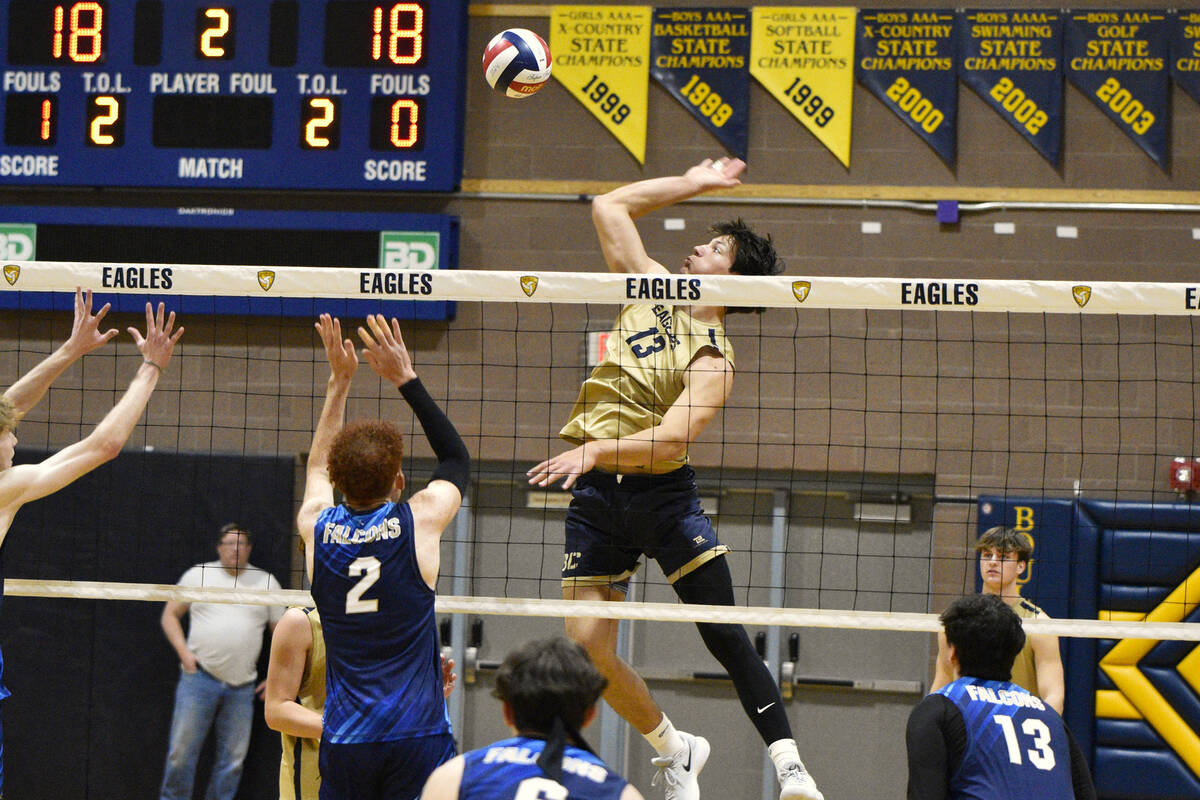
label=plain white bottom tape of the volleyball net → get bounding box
[5,578,1200,642]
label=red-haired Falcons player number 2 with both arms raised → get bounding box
[296,314,470,800]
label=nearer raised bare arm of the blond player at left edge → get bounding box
[0,303,184,525]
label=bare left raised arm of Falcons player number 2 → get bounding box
[296,314,359,578]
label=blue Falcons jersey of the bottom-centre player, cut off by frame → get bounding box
[458,736,628,800]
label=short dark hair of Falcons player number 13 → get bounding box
[938,595,1025,680]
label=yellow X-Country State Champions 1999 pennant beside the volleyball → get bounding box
[550,6,650,164]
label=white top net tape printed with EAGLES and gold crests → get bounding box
[11,261,1200,315]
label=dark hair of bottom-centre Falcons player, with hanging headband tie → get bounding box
[493,636,608,781]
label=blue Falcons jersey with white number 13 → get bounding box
[935,678,1075,800]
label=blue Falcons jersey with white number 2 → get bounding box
[312,503,450,744]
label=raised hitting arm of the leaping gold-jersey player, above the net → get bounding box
[592,158,746,272]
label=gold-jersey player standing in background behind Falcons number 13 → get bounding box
[931,525,1067,714]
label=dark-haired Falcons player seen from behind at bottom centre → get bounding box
[421,636,642,800]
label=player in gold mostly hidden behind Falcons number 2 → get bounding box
[263,607,458,800]
